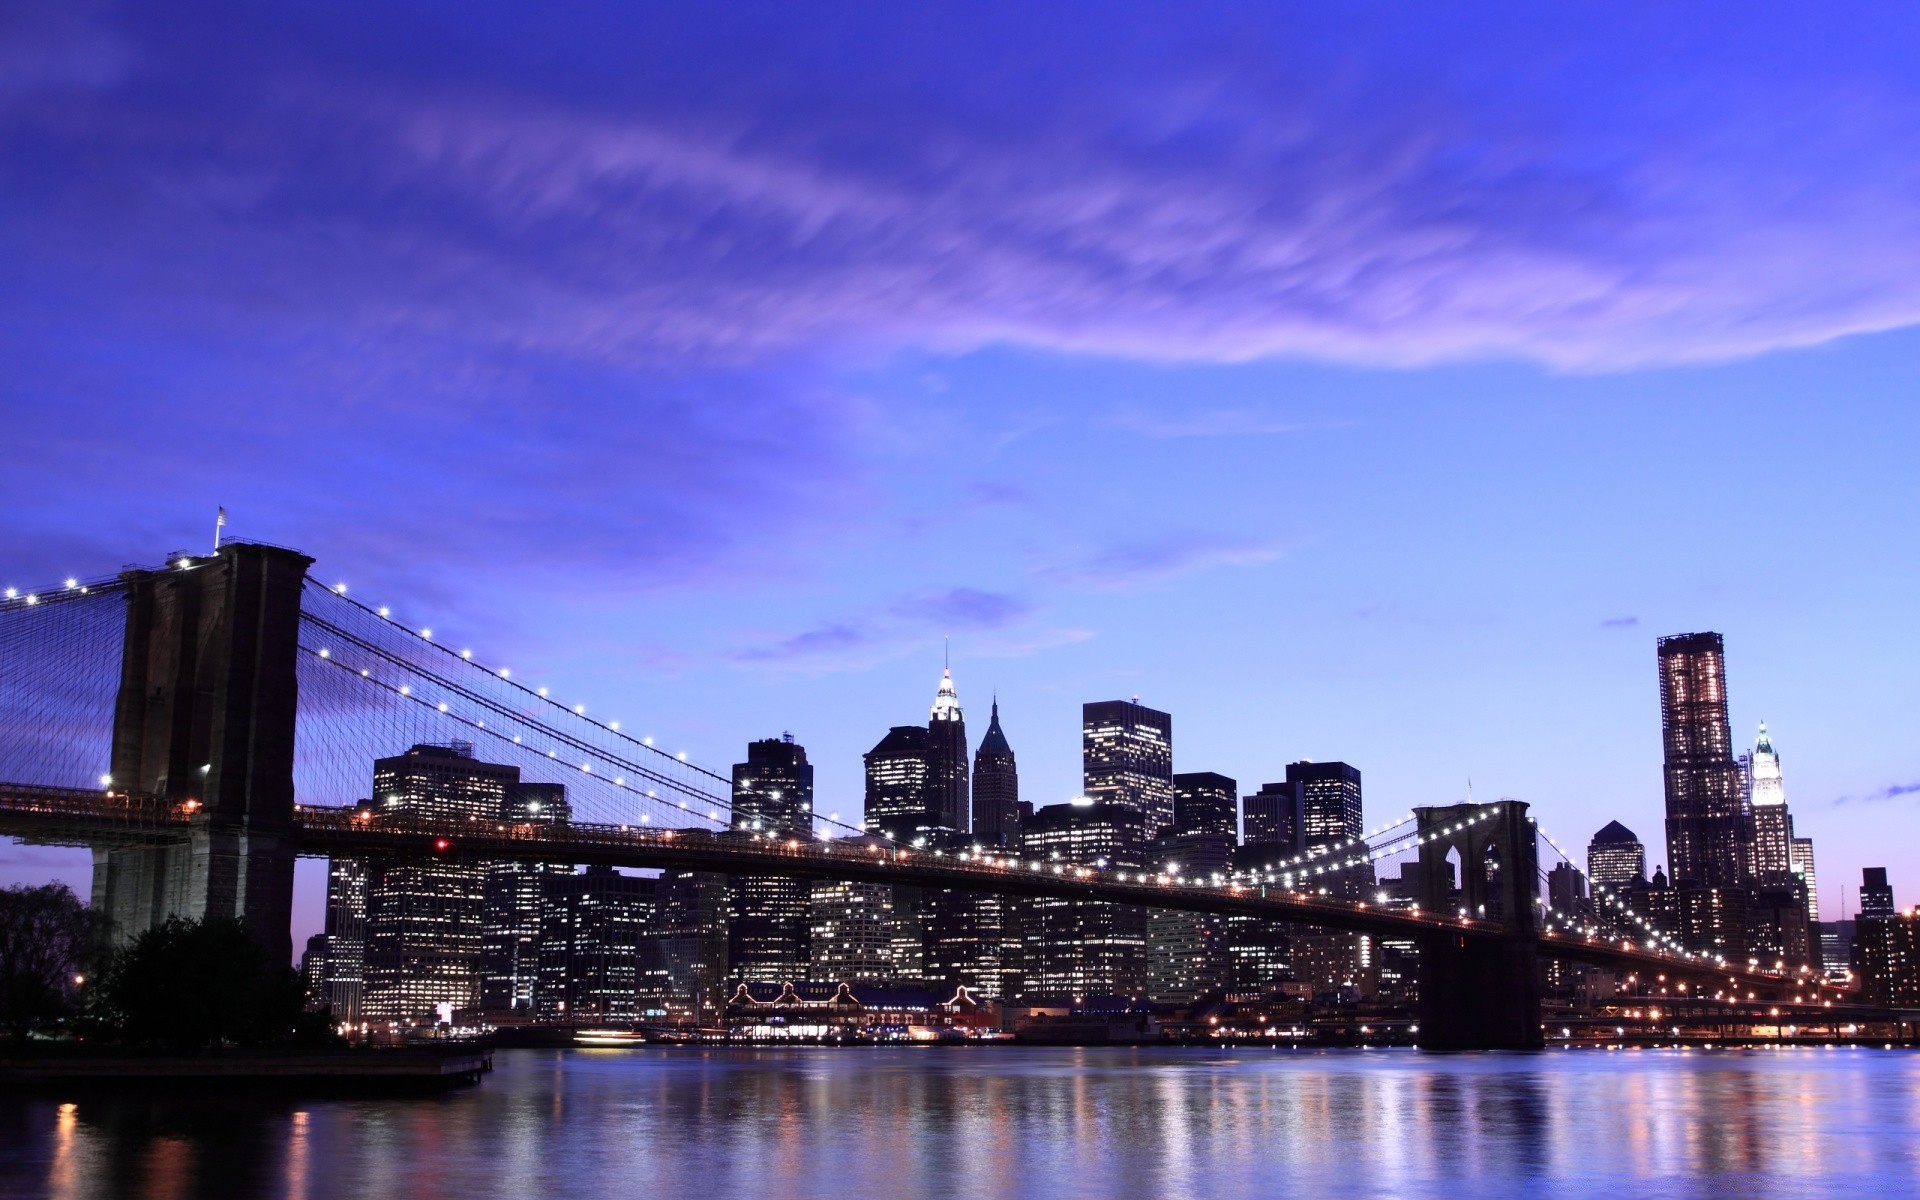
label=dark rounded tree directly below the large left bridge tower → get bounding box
[98,918,324,1050]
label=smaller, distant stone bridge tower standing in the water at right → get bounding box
[1413,801,1544,1050]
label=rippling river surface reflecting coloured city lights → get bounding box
[0,1046,1920,1200]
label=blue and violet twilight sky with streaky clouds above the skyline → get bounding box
[0,0,1920,933]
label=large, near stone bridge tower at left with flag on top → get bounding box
[92,543,313,962]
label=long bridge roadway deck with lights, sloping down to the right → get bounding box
[0,783,1851,1002]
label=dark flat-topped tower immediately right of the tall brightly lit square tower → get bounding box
[1146,821,1236,1004]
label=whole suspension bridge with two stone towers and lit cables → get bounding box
[0,541,1849,1048]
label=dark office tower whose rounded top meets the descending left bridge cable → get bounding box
[728,733,814,983]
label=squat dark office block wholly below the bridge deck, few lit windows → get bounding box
[536,866,659,1025]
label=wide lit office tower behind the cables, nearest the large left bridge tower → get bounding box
[363,743,520,1021]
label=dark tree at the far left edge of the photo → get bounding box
[0,883,86,1048]
